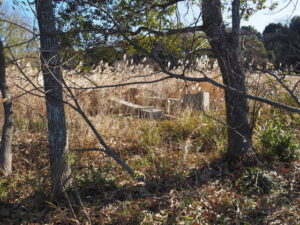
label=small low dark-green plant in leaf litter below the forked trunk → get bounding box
[236,168,279,194]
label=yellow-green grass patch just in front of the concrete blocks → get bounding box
[138,111,226,151]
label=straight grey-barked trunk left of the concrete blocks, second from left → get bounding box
[36,0,71,196]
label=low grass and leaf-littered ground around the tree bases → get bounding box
[0,97,300,225]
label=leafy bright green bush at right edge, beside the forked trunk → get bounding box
[260,120,300,161]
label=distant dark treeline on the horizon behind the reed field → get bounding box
[57,16,300,73]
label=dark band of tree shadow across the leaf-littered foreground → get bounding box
[0,155,299,224]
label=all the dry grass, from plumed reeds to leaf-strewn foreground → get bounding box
[0,60,300,225]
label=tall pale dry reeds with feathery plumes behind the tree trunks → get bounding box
[0,57,298,153]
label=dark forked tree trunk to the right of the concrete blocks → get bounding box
[202,0,252,159]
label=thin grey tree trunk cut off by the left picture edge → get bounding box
[0,40,14,175]
